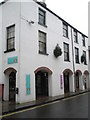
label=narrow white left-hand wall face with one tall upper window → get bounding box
[2,2,20,101]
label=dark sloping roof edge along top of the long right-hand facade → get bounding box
[36,2,88,38]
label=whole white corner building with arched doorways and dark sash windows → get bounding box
[0,0,89,103]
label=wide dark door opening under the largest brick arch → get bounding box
[35,71,48,99]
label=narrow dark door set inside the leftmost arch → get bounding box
[9,72,16,102]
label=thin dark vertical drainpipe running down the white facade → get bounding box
[71,28,76,92]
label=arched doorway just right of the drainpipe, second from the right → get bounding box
[75,70,83,91]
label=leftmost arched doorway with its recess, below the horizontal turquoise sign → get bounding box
[4,68,17,102]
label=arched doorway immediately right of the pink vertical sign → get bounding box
[63,69,73,93]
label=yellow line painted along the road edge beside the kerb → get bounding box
[0,93,88,118]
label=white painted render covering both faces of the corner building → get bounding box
[0,0,88,103]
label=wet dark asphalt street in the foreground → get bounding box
[3,93,89,119]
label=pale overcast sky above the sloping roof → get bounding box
[0,0,89,35]
